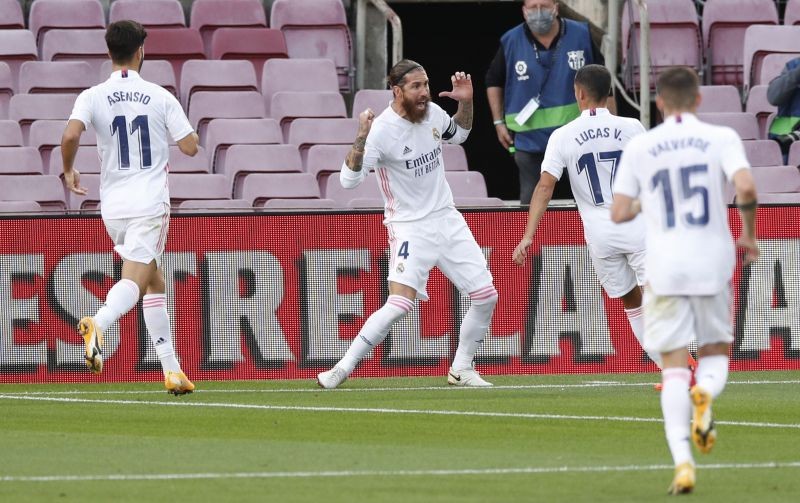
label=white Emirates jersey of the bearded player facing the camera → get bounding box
[362,103,468,223]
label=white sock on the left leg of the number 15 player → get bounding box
[661,367,694,466]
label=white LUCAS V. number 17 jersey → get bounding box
[542,108,645,258]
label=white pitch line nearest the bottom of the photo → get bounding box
[0,461,800,482]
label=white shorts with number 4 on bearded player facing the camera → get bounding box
[386,210,492,300]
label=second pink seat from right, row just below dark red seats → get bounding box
[180,60,258,110]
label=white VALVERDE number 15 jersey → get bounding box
[614,113,750,295]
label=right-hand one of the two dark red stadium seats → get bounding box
[211,28,289,90]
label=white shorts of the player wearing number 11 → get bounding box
[103,212,169,267]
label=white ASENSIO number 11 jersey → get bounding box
[70,70,193,218]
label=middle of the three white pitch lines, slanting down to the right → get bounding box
[0,394,800,429]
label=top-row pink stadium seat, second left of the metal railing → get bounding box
[189,0,267,55]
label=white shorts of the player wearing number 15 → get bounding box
[643,286,733,353]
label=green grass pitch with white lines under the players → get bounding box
[0,372,800,503]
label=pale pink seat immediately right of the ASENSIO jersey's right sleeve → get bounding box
[189,91,264,138]
